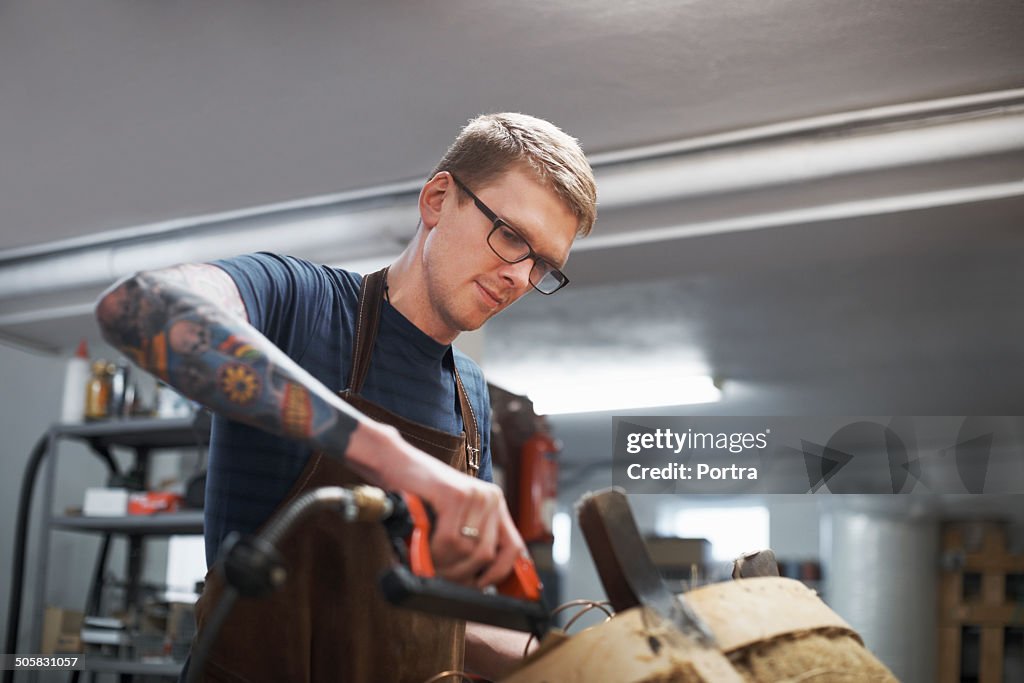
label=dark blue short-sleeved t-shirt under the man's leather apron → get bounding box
[205,253,492,565]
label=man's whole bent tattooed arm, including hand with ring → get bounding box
[96,264,525,586]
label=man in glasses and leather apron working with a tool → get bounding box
[96,114,596,682]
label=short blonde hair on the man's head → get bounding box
[430,113,597,237]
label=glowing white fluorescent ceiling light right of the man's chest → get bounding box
[499,366,722,415]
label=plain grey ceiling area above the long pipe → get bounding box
[0,0,1024,249]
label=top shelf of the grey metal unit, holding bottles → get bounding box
[52,411,210,449]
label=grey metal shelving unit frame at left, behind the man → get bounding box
[29,413,210,680]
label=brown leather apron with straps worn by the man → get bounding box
[196,268,480,683]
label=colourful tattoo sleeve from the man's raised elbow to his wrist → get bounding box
[96,266,361,456]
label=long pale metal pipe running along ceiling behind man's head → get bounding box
[0,90,1024,328]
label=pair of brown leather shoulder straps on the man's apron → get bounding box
[346,266,480,476]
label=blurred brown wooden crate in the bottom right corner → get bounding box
[938,521,1024,683]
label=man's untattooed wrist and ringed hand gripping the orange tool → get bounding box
[346,423,526,588]
